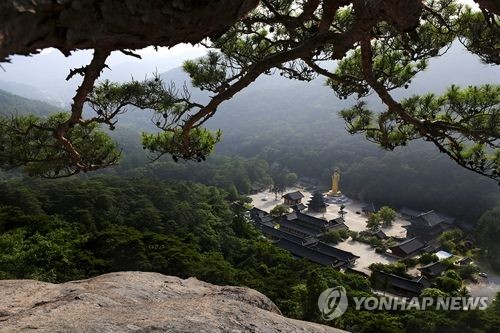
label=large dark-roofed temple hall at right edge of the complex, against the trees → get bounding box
[404,210,450,242]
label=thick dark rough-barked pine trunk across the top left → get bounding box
[0,0,259,61]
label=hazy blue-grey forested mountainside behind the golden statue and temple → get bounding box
[2,43,500,221]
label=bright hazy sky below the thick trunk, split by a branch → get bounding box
[0,45,205,105]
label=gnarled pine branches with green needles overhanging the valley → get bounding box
[0,0,500,180]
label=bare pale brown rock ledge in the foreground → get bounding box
[0,272,341,333]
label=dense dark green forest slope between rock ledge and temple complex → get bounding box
[0,176,500,332]
